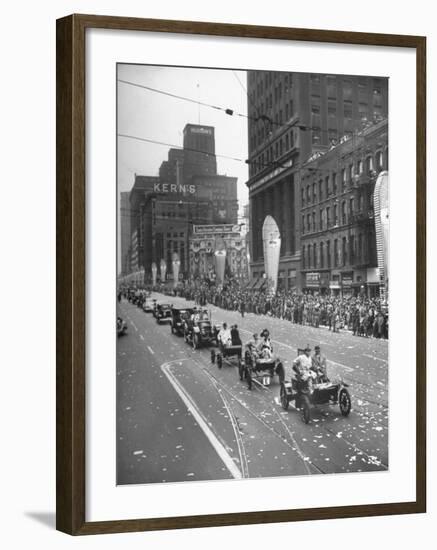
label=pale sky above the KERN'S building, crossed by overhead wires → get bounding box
[118,64,248,207]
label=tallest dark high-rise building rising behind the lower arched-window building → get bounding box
[247,71,388,289]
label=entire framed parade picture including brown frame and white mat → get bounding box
[56,15,426,535]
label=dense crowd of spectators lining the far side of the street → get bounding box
[159,279,388,338]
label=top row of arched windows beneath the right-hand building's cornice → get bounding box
[301,151,384,206]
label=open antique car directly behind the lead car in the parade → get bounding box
[238,348,285,390]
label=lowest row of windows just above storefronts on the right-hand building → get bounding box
[302,233,366,269]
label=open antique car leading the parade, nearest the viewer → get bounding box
[280,349,352,424]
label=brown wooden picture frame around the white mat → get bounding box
[56,15,426,535]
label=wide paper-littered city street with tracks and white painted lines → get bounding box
[117,293,389,484]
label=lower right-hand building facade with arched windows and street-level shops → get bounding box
[300,119,388,297]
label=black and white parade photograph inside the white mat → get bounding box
[116,63,390,485]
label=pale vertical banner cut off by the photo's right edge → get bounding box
[373,174,389,298]
